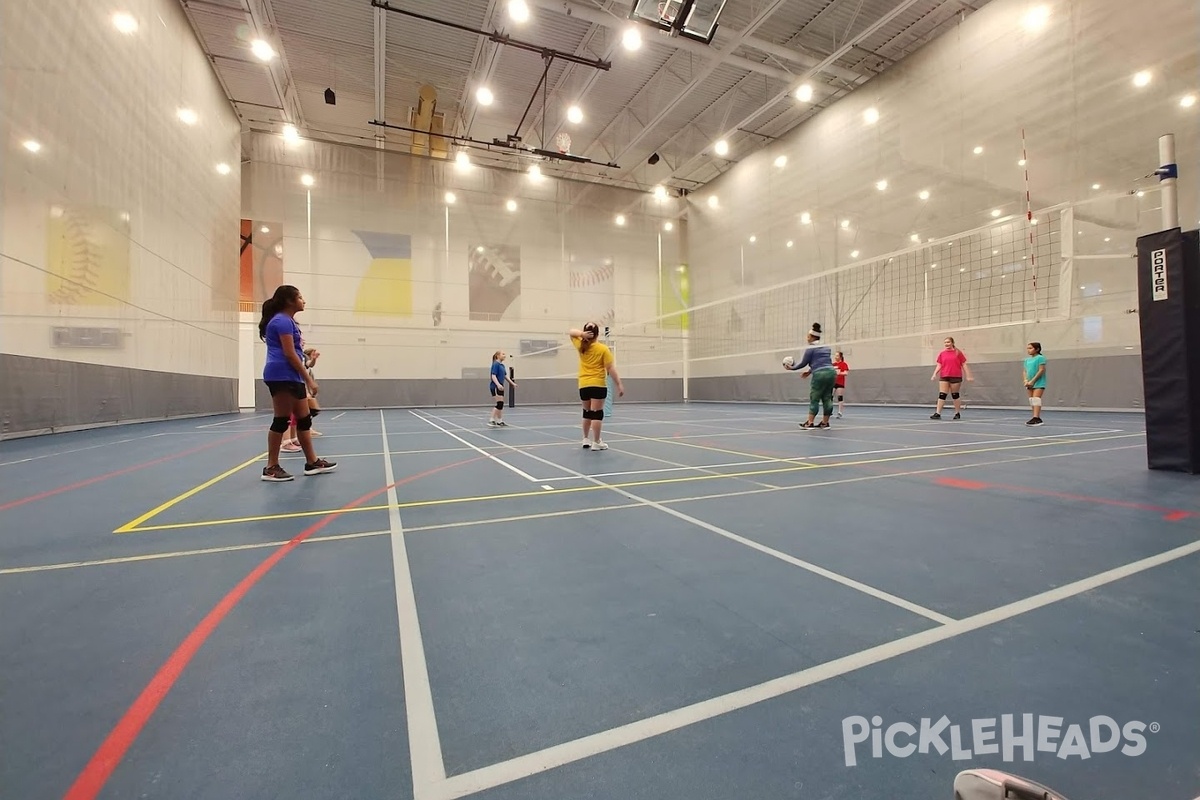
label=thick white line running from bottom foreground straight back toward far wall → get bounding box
[379,410,446,800]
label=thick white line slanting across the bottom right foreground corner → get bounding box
[428,532,1200,800]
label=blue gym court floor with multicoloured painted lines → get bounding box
[0,402,1200,800]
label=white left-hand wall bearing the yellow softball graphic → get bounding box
[0,0,240,380]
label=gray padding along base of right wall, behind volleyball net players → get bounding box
[688,355,1144,410]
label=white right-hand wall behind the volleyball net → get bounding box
[689,0,1200,375]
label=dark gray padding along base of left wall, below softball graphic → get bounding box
[0,354,238,438]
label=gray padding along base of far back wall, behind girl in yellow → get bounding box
[254,378,683,410]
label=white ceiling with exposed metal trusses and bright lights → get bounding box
[180,0,988,188]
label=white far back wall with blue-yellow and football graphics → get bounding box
[244,134,680,380]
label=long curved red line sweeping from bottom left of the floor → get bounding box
[64,457,482,800]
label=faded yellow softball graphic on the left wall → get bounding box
[46,206,130,306]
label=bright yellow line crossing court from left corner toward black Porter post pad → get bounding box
[114,433,1144,533]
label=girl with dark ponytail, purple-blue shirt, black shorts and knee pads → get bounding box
[258,285,337,481]
